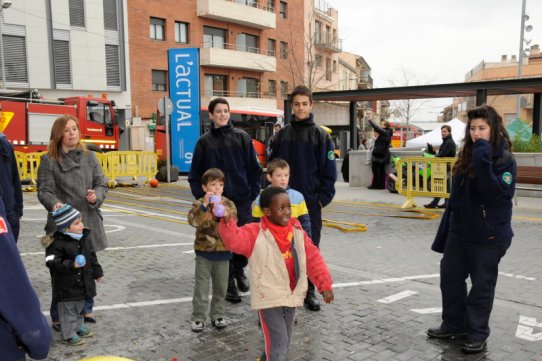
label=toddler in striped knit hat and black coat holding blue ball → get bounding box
[42,204,103,346]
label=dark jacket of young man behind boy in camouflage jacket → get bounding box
[188,121,262,203]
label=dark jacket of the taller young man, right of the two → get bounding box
[269,113,337,209]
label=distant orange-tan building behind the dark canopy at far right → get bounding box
[452,45,542,124]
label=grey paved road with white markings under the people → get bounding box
[19,181,542,361]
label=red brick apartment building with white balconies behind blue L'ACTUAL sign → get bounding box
[128,0,304,118]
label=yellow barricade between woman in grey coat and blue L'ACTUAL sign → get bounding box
[98,151,158,181]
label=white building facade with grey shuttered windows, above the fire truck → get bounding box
[0,0,131,112]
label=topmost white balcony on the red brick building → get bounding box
[197,0,277,29]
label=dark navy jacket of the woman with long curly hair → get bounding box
[431,140,516,252]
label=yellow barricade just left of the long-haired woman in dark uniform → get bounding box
[395,157,456,208]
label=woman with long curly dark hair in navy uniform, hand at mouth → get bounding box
[427,106,516,353]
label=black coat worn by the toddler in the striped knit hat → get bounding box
[45,229,103,302]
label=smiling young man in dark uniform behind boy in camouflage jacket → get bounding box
[188,98,262,303]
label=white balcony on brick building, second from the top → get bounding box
[200,42,277,72]
